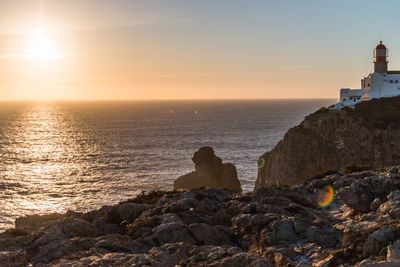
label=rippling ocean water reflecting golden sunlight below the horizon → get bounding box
[0,99,334,231]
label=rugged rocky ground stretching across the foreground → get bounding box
[0,167,400,267]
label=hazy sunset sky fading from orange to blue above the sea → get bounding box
[0,0,400,100]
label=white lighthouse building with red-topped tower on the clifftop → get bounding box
[332,42,400,109]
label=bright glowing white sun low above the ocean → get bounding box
[26,32,64,61]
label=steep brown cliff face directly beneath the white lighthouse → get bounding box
[255,97,400,189]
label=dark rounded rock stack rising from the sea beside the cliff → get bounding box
[174,147,242,192]
